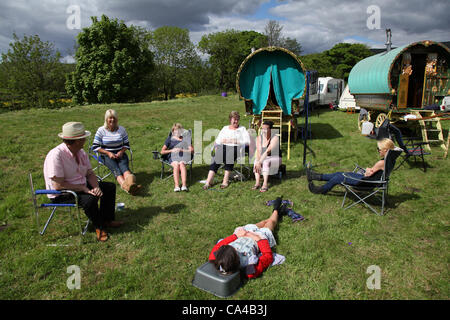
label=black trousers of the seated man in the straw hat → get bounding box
[52,181,116,229]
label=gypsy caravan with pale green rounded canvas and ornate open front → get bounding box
[348,40,450,149]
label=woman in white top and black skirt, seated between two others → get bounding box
[203,111,250,190]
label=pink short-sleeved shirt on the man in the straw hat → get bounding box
[44,143,92,198]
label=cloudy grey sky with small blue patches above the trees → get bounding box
[0,0,450,62]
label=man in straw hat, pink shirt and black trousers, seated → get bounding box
[44,122,123,242]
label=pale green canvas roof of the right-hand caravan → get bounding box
[348,40,449,94]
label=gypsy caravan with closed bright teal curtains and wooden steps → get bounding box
[236,47,306,159]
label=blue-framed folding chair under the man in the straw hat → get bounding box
[29,173,90,236]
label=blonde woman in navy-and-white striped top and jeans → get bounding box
[92,109,141,195]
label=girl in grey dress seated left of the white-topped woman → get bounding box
[160,123,194,192]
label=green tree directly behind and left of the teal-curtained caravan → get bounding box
[198,30,267,90]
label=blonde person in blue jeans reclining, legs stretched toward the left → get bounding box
[306,139,395,194]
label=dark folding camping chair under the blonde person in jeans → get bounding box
[341,148,402,215]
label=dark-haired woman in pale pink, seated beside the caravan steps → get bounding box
[252,121,281,192]
